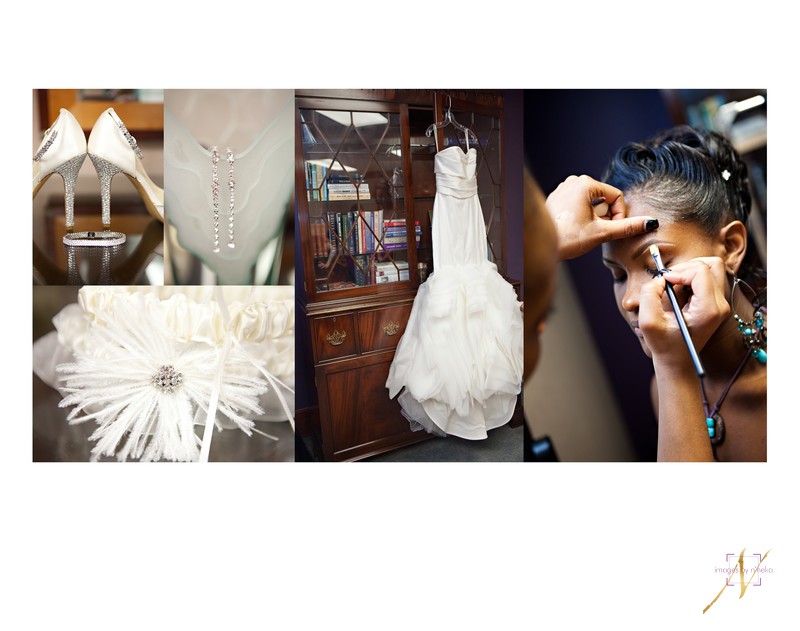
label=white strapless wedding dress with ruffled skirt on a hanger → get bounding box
[386,145,523,440]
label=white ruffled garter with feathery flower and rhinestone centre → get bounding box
[34,287,294,461]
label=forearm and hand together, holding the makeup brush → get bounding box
[639,258,730,462]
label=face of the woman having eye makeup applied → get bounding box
[603,194,724,357]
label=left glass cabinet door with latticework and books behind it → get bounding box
[299,101,420,297]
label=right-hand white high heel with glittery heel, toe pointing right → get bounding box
[88,107,164,228]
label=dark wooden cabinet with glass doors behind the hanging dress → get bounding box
[295,90,505,460]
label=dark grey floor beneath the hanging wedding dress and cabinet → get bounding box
[363,426,522,462]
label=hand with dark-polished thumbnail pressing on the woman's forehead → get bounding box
[545,175,658,260]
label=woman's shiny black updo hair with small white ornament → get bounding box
[603,126,755,284]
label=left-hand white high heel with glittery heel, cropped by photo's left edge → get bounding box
[33,108,86,232]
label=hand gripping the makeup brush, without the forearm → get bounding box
[639,257,731,363]
